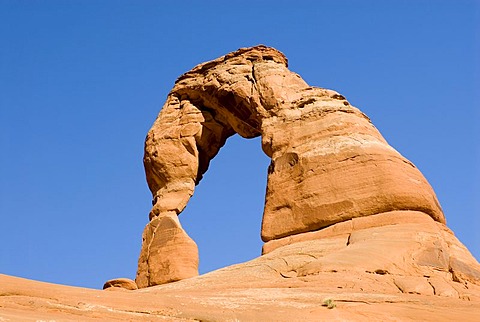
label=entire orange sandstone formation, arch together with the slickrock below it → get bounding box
[0,46,480,322]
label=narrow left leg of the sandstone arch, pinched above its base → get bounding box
[136,92,234,288]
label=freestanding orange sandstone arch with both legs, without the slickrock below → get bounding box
[136,45,445,287]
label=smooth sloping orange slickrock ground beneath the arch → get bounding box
[0,212,480,322]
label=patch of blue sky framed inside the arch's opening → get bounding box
[179,135,270,274]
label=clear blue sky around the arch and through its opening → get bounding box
[0,0,480,288]
